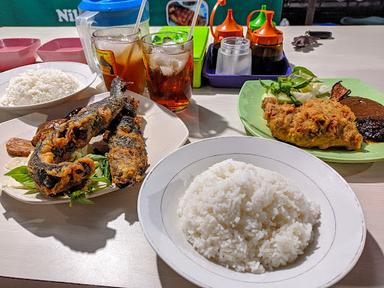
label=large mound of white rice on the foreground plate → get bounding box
[178,159,320,273]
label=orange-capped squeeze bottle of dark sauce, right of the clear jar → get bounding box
[247,10,284,75]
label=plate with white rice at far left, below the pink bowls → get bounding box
[0,61,97,112]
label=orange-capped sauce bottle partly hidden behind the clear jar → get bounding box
[209,0,243,68]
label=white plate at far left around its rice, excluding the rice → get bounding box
[0,61,97,112]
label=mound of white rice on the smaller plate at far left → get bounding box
[0,69,80,106]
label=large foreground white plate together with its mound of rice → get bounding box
[138,136,366,288]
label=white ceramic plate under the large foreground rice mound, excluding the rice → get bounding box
[138,137,366,288]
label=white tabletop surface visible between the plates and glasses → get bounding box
[0,26,384,288]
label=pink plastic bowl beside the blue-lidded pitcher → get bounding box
[37,38,87,64]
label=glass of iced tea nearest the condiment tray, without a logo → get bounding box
[141,32,193,112]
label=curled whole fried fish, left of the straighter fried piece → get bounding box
[28,78,126,196]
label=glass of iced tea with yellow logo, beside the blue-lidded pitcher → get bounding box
[92,27,145,94]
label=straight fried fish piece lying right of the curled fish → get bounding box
[108,102,148,187]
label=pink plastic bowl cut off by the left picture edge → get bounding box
[0,38,41,71]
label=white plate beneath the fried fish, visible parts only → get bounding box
[0,92,188,204]
